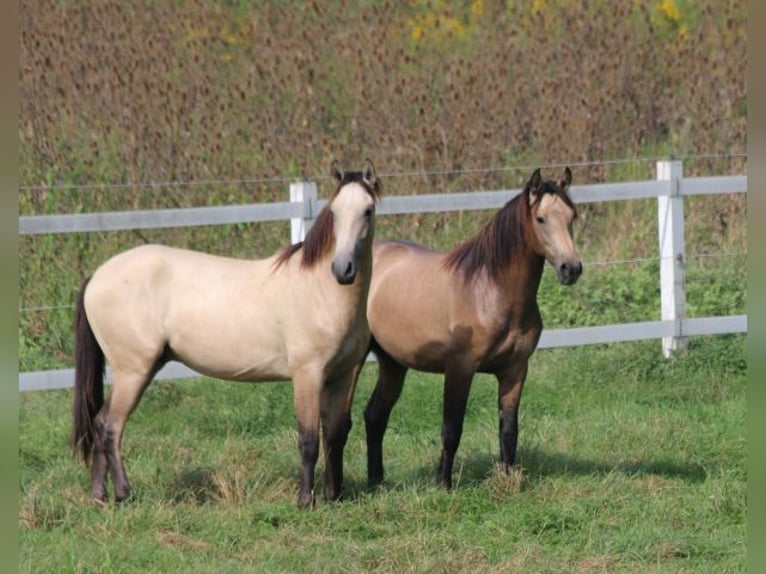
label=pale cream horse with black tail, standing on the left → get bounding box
[72,160,380,507]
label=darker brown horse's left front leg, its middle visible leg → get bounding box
[437,361,474,488]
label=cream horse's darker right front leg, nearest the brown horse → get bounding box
[320,363,362,500]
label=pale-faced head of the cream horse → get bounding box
[330,159,380,285]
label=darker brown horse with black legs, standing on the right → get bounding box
[364,168,582,488]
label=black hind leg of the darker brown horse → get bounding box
[364,350,407,487]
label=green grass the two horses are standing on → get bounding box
[19,336,747,573]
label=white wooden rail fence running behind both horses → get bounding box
[19,161,747,391]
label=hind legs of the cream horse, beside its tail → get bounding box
[99,372,153,502]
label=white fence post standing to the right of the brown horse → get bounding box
[657,161,688,357]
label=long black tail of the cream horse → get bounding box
[72,277,104,464]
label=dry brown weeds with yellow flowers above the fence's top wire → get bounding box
[20,0,747,201]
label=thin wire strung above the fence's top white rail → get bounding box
[18,153,747,192]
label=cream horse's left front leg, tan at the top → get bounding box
[293,369,322,508]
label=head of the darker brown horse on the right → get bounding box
[524,167,582,285]
